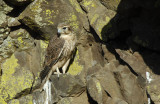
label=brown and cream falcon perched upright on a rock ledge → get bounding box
[40,23,77,90]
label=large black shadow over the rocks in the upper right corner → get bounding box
[101,0,160,75]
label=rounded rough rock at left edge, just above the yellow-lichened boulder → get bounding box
[0,29,34,58]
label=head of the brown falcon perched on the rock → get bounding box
[57,23,72,36]
